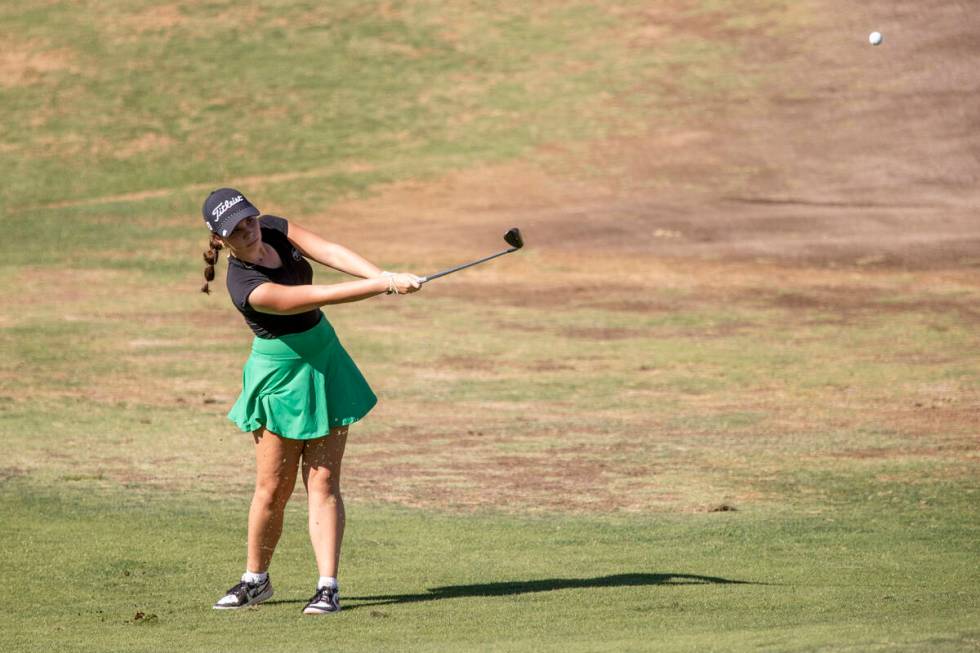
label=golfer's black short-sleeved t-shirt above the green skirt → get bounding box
[227,215,322,338]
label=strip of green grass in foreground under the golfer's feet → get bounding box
[0,478,980,651]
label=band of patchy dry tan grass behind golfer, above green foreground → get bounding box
[0,241,980,512]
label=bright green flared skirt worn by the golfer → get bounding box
[228,310,378,440]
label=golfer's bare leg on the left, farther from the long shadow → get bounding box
[246,428,304,573]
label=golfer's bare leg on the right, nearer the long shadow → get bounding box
[303,426,347,577]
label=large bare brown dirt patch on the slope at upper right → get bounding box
[316,0,980,269]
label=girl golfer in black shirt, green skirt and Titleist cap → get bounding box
[201,188,420,614]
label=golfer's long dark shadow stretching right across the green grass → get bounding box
[267,574,765,611]
